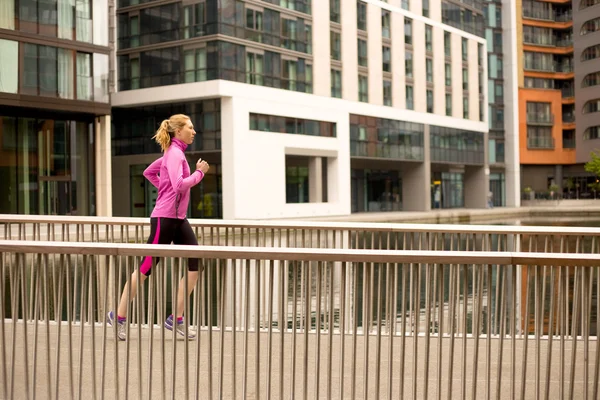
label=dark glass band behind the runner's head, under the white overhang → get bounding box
[111,99,221,155]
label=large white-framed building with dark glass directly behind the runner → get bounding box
[112,0,519,219]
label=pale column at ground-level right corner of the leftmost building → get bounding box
[94,115,112,217]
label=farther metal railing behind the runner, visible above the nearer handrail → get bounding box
[5,216,600,253]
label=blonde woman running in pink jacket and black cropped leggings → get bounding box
[107,114,209,340]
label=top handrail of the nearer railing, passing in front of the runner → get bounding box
[0,240,600,267]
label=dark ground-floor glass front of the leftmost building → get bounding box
[0,109,96,215]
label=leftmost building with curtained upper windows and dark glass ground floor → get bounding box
[0,0,112,215]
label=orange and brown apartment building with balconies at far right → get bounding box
[518,0,600,197]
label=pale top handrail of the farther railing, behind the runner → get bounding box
[0,212,600,236]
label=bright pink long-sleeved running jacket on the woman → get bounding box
[144,138,204,219]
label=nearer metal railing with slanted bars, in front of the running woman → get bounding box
[0,241,600,399]
